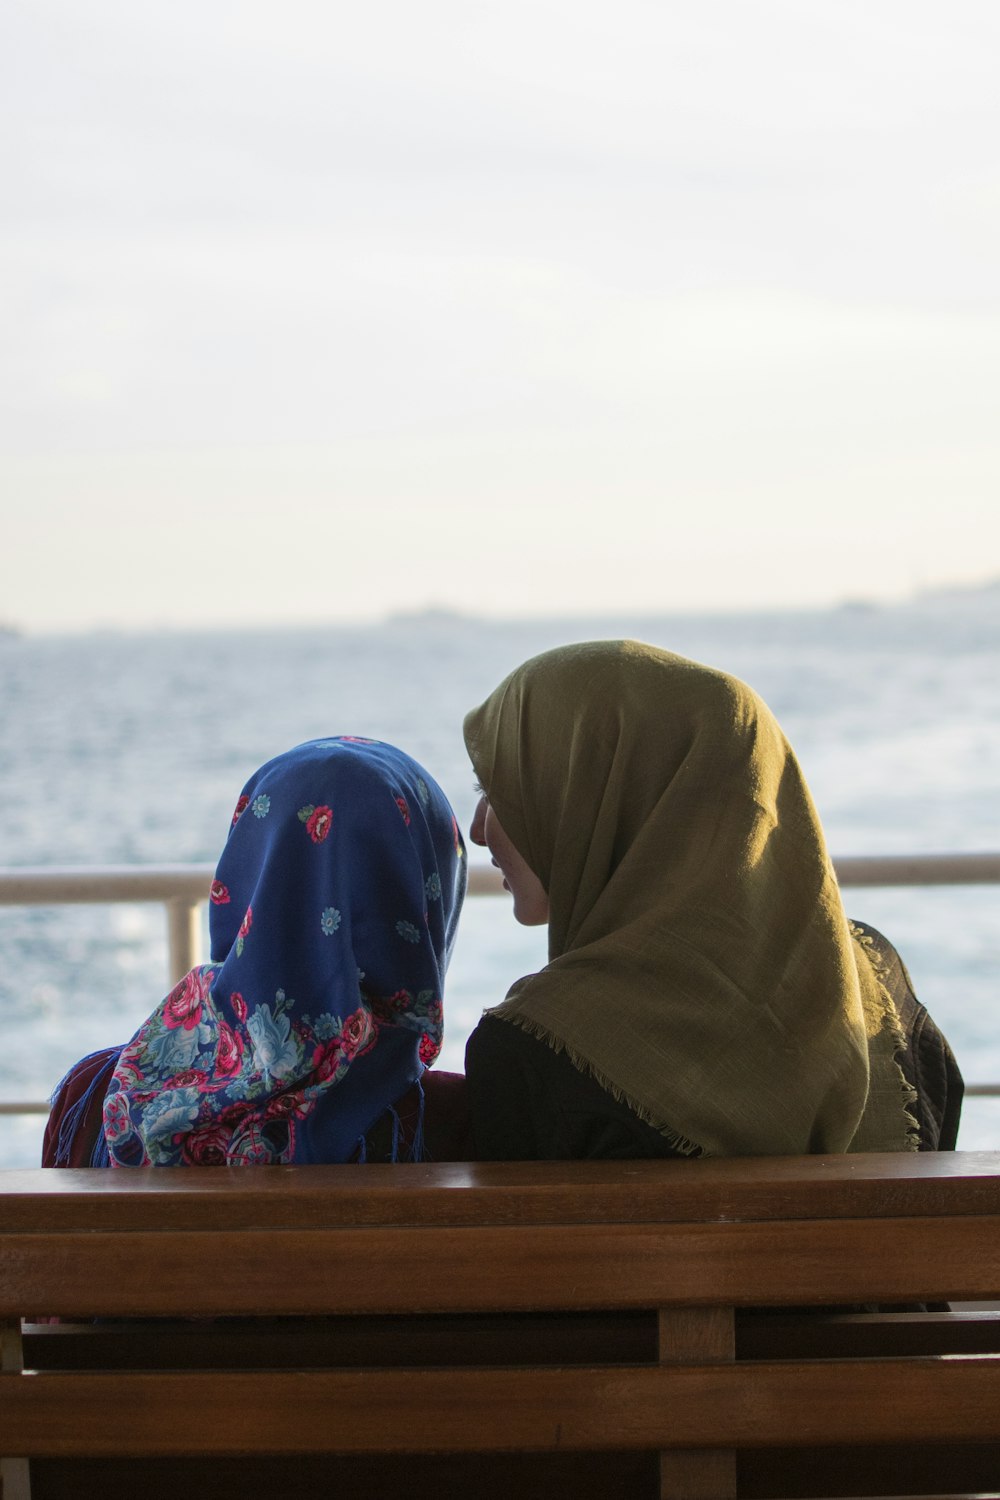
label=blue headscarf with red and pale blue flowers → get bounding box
[103,737,466,1167]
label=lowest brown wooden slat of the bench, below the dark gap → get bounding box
[0,1355,1000,1457]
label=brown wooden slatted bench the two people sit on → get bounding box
[0,1154,1000,1500]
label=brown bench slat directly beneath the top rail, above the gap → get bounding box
[0,1217,1000,1317]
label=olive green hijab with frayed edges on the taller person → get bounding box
[465,641,916,1157]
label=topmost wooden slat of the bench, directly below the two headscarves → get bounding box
[0,1152,1000,1235]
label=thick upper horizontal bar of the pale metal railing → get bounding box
[0,852,1000,906]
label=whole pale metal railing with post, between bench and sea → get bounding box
[0,852,1000,1115]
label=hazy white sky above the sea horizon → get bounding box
[0,0,1000,629]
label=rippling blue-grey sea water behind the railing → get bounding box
[0,588,1000,1166]
